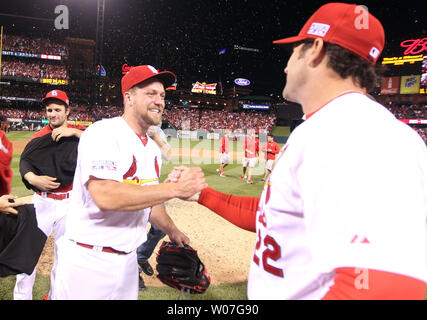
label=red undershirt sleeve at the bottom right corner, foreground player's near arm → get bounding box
[323,268,426,300]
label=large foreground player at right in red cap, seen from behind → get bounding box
[171,3,427,300]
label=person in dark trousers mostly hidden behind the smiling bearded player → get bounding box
[136,124,172,291]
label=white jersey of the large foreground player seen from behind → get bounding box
[248,92,427,299]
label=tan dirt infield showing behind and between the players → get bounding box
[13,141,256,286]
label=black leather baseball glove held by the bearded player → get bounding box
[156,241,210,294]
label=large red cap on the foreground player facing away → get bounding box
[273,3,385,64]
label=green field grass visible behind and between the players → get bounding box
[0,132,264,300]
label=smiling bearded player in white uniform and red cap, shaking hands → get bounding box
[53,65,206,300]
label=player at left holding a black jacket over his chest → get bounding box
[13,90,82,300]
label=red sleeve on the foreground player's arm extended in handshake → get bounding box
[198,188,259,232]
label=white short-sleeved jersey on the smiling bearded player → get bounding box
[66,117,162,252]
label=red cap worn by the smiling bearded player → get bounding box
[122,65,176,96]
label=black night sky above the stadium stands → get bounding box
[0,0,427,94]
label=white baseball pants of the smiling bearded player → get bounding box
[52,237,139,300]
